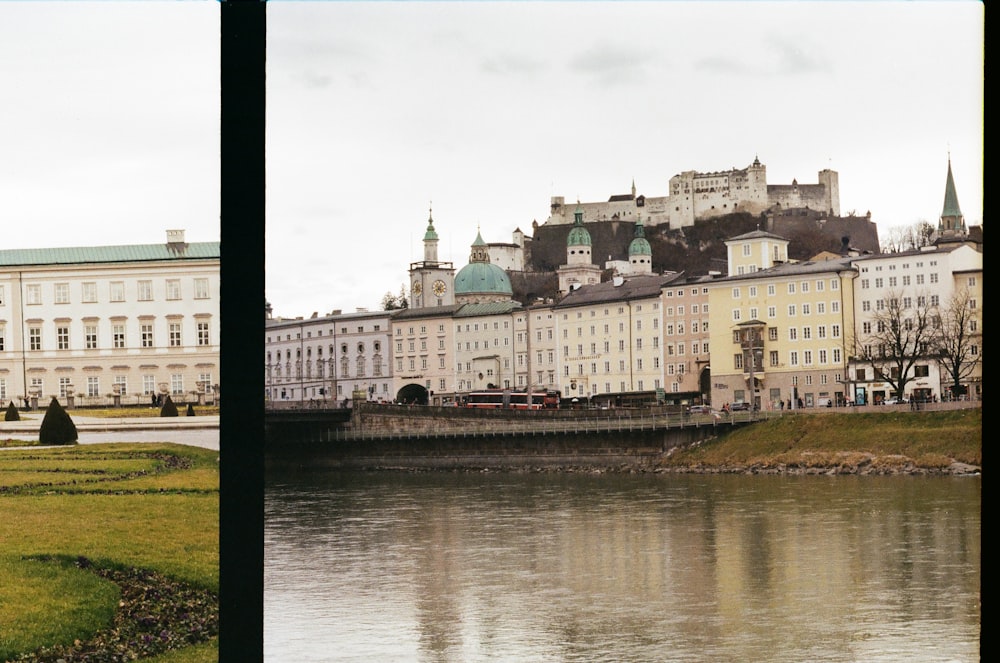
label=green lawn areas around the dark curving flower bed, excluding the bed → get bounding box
[0,444,219,663]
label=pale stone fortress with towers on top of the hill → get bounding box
[545,158,840,229]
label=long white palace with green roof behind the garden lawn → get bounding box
[0,230,219,405]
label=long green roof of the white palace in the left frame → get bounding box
[0,242,220,267]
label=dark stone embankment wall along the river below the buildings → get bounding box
[267,406,716,470]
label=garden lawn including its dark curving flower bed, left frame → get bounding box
[0,444,219,663]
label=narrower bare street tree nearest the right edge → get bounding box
[935,289,983,396]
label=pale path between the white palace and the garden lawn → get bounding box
[0,411,219,450]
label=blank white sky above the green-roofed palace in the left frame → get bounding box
[0,1,220,249]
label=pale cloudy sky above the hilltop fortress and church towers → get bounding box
[266,1,984,317]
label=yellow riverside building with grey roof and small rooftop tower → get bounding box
[708,231,857,409]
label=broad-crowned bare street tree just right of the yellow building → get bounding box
[855,290,940,398]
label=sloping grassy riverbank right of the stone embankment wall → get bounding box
[662,408,983,474]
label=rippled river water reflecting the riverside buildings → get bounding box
[264,471,982,663]
